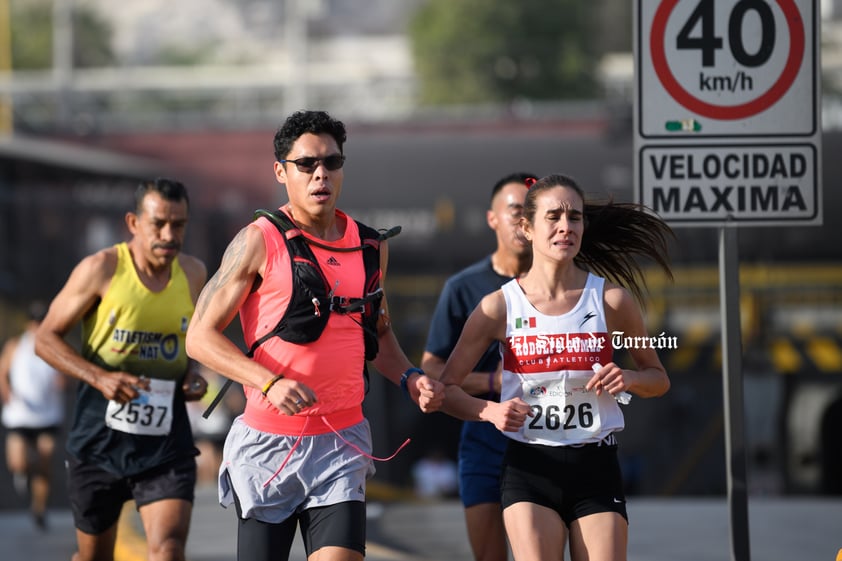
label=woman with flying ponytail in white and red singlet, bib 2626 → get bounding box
[419,175,671,561]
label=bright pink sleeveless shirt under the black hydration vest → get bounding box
[240,210,365,434]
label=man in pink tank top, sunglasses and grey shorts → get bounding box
[187,111,443,561]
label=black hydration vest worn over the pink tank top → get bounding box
[248,209,401,360]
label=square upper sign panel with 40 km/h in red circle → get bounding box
[637,0,819,137]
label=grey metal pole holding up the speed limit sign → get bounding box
[719,226,751,561]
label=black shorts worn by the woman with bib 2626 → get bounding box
[501,440,628,527]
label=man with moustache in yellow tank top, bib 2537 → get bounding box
[36,179,207,561]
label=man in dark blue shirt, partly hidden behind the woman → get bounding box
[421,173,535,561]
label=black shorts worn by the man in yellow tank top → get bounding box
[67,450,196,535]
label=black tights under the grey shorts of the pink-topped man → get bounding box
[234,486,366,561]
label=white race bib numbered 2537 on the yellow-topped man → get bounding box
[105,378,175,436]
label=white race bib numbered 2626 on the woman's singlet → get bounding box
[521,379,602,444]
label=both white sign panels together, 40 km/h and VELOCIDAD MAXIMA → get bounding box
[635,0,822,226]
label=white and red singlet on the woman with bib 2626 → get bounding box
[500,274,625,446]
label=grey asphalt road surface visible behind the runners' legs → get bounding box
[0,487,842,561]
